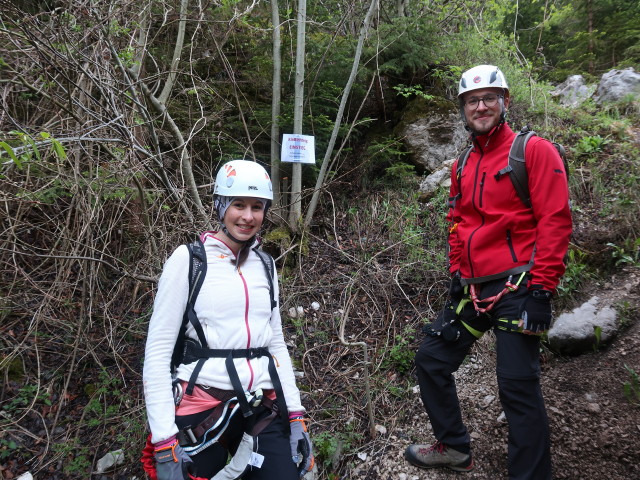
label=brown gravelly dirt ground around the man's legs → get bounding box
[350,268,640,480]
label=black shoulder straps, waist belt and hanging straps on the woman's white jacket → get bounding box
[171,239,289,440]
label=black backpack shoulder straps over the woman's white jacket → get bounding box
[171,239,278,373]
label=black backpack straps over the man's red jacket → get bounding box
[456,126,569,208]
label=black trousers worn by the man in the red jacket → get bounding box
[415,279,552,480]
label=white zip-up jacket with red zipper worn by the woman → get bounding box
[143,233,304,443]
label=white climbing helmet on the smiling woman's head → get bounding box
[213,160,273,200]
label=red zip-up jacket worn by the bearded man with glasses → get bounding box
[447,124,571,292]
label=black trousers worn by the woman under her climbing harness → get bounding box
[176,407,298,480]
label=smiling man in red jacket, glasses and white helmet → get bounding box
[405,65,571,480]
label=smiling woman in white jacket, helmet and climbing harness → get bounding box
[143,160,313,480]
